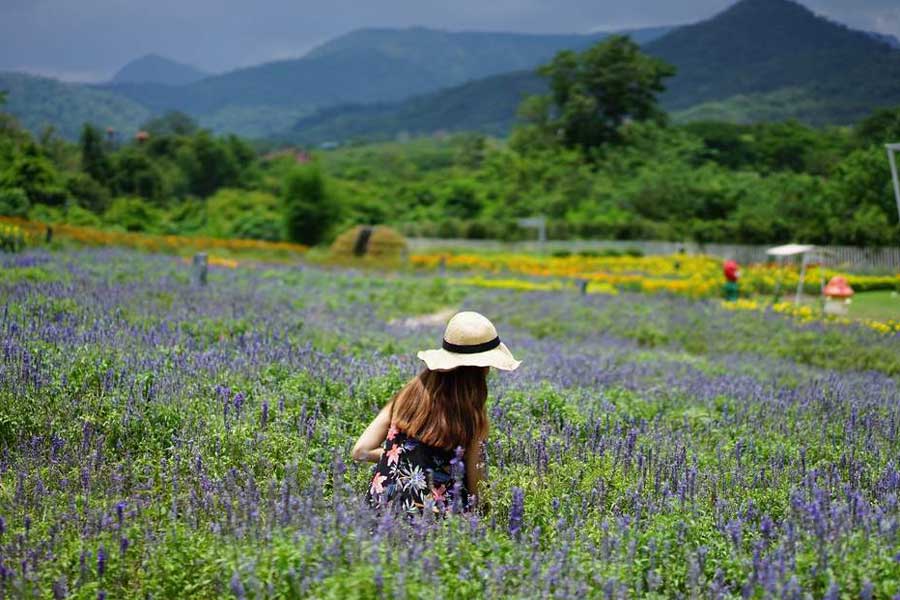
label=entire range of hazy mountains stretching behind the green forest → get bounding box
[6,0,900,143]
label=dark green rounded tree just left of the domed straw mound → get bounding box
[283,165,340,245]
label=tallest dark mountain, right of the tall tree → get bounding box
[644,0,900,123]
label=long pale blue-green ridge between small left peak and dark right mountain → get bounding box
[101,27,669,135]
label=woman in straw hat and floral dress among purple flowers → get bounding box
[353,312,520,512]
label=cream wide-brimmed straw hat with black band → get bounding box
[417,312,521,371]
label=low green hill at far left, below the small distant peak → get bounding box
[0,72,151,139]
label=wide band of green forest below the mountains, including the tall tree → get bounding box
[0,37,900,245]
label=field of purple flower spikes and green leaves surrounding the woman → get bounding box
[0,250,900,598]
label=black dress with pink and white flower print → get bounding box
[366,425,468,513]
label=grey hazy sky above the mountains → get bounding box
[0,0,900,81]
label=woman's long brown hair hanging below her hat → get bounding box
[391,367,488,449]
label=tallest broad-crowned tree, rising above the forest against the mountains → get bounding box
[528,36,675,149]
